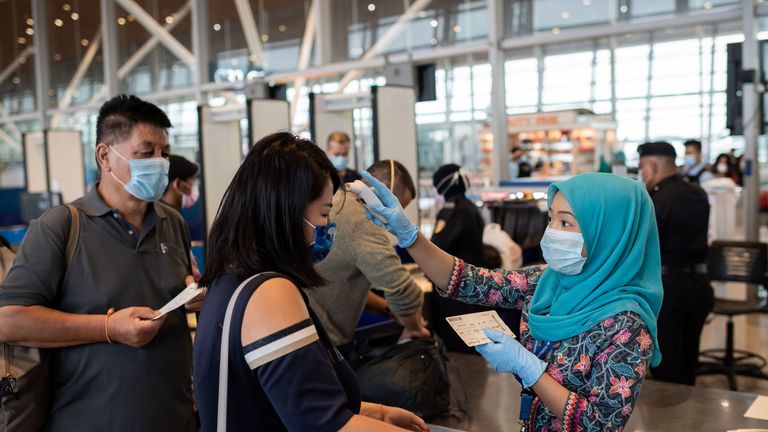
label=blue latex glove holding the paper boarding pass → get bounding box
[475,329,547,388]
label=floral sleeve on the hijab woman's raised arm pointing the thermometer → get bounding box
[438,258,543,309]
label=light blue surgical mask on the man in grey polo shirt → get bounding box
[109,146,171,201]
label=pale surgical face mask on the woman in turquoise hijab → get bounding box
[541,227,587,276]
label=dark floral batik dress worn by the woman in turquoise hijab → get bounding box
[441,259,653,432]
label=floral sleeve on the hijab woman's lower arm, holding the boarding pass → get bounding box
[540,313,653,431]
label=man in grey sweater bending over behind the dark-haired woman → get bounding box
[307,160,429,346]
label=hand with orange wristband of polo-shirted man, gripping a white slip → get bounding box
[107,307,165,348]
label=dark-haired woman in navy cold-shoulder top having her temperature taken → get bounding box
[194,133,427,431]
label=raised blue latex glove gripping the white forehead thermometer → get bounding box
[360,171,419,248]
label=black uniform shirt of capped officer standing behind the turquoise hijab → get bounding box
[651,175,709,267]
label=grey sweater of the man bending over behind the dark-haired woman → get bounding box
[307,192,423,345]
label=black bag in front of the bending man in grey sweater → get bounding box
[350,338,451,419]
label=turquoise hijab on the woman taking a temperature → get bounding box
[528,173,663,366]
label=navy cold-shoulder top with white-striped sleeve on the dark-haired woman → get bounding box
[193,273,360,432]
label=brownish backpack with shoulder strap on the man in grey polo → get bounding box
[0,204,80,432]
